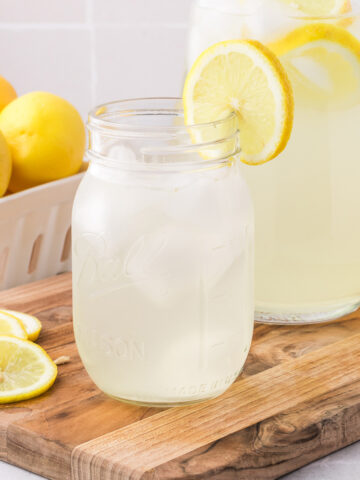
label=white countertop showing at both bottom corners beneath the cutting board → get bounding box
[0,442,360,480]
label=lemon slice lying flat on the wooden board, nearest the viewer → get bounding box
[0,335,57,403]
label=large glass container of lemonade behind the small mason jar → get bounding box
[188,0,360,323]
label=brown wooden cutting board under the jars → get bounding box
[0,274,360,480]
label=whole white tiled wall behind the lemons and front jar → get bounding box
[0,0,193,118]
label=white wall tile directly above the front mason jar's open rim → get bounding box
[95,26,186,103]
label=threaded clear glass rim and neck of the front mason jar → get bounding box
[87,97,241,170]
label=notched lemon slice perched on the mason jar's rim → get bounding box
[183,40,294,165]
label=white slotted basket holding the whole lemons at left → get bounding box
[0,173,83,290]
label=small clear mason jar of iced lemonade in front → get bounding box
[73,99,254,406]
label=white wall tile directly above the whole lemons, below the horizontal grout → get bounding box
[0,29,91,114]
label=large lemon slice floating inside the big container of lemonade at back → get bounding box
[269,23,360,108]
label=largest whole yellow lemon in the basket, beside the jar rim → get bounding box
[0,92,85,192]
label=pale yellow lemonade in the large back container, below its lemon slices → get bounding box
[244,92,360,312]
